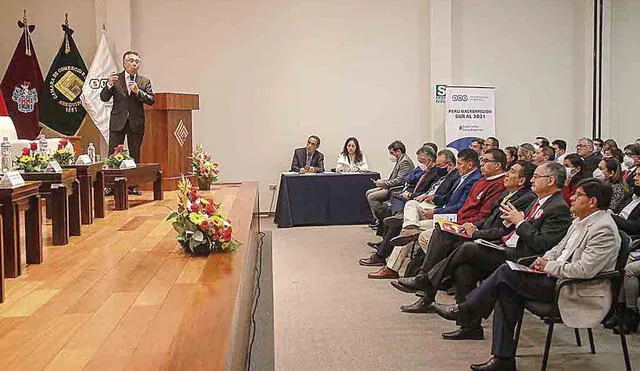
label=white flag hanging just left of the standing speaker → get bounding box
[80,31,118,143]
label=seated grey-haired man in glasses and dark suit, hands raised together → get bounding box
[394,161,571,326]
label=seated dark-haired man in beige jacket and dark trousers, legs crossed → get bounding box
[435,179,621,371]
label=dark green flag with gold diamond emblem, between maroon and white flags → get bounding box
[39,14,87,136]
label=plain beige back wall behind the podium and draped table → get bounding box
[133,0,429,210]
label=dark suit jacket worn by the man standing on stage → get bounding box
[100,71,154,133]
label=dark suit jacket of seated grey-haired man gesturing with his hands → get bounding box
[507,192,572,261]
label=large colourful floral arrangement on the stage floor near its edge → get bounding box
[167,176,239,255]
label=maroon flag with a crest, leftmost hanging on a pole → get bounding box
[0,15,42,139]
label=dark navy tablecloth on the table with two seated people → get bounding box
[275,172,380,228]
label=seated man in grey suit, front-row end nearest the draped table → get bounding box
[366,140,414,228]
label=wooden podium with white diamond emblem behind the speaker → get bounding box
[140,93,200,191]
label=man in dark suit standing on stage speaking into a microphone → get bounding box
[100,51,154,195]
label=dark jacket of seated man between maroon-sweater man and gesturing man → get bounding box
[472,188,537,241]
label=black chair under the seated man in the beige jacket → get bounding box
[514,231,631,371]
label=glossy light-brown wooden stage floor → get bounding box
[0,183,257,370]
